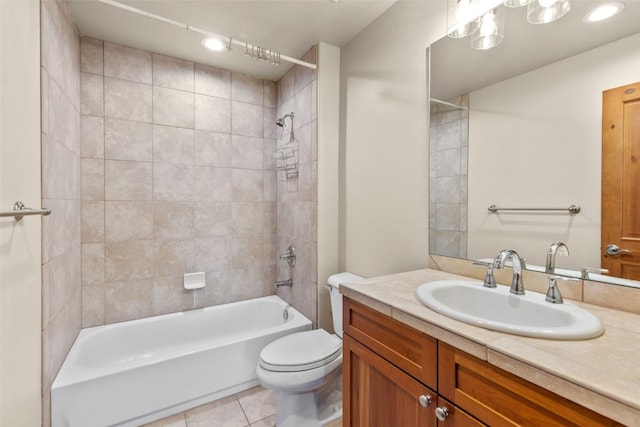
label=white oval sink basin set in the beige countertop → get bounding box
[416,280,604,340]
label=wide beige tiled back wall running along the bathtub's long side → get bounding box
[80,38,277,327]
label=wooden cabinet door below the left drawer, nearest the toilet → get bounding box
[343,334,437,427]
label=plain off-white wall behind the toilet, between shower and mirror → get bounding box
[340,1,446,276]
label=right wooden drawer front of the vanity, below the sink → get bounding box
[438,343,621,427]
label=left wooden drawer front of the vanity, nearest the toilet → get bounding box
[343,298,438,389]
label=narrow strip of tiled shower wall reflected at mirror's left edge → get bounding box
[429,95,469,258]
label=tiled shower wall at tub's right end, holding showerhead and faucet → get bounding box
[270,46,318,325]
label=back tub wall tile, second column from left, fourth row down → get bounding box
[104,160,152,200]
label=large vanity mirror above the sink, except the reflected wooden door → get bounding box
[429,1,640,286]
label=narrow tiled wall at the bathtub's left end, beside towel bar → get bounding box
[40,1,82,426]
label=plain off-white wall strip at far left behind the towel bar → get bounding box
[0,0,41,427]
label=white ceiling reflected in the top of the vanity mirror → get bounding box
[431,0,640,101]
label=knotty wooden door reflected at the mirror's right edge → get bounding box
[601,82,640,280]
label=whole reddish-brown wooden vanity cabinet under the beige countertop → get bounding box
[343,297,621,427]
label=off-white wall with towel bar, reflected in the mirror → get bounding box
[468,35,640,268]
